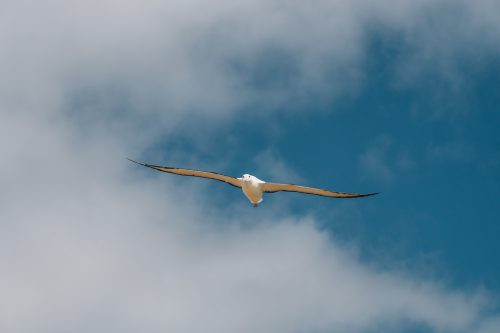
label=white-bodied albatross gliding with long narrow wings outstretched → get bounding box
[128,158,378,207]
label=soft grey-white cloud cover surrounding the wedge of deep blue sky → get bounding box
[0,1,500,332]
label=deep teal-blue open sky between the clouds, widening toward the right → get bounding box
[152,16,500,291]
